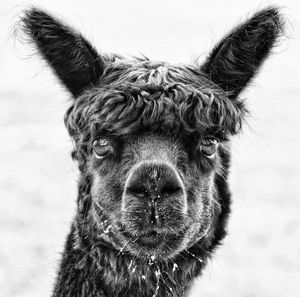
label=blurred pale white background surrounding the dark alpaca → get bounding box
[0,0,300,297]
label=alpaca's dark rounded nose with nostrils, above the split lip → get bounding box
[125,162,183,204]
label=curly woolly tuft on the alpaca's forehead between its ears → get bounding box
[67,59,245,140]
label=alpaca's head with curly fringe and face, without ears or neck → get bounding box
[62,60,243,259]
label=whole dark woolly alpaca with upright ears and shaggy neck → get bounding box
[22,7,283,297]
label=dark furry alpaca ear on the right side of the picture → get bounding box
[201,8,283,99]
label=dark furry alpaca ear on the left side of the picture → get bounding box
[21,8,104,97]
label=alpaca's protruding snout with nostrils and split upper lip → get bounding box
[123,162,187,231]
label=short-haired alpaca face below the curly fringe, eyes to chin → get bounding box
[90,133,220,258]
